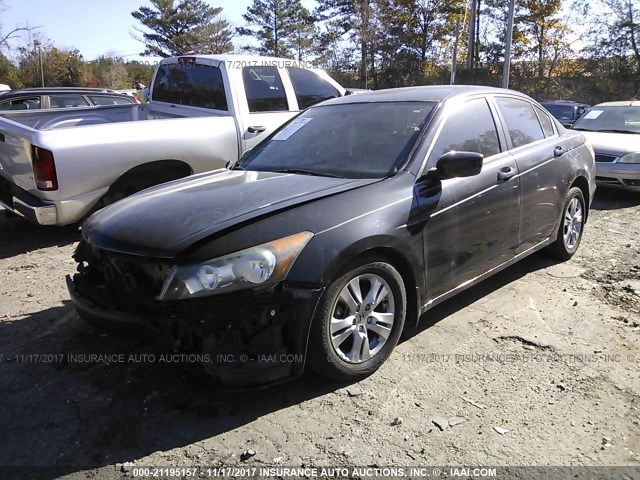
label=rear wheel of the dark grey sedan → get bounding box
[546,187,587,261]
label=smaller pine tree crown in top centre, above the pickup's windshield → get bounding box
[238,0,313,57]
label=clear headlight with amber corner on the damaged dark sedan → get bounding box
[158,232,313,300]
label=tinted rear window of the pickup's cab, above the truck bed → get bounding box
[152,62,227,111]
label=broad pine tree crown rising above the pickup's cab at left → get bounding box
[131,0,233,57]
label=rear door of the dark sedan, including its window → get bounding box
[495,96,569,253]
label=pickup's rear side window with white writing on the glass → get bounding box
[242,66,289,113]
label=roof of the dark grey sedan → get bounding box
[322,85,532,105]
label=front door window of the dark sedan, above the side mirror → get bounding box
[432,98,500,159]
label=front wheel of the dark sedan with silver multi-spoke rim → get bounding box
[308,260,407,381]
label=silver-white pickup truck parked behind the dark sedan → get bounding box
[0,55,346,225]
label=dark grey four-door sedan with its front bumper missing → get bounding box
[67,86,595,386]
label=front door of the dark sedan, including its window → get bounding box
[415,97,520,300]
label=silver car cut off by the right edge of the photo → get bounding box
[573,100,640,192]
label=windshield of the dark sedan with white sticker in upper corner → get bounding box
[235,102,435,178]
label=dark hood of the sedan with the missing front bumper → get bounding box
[82,170,379,258]
